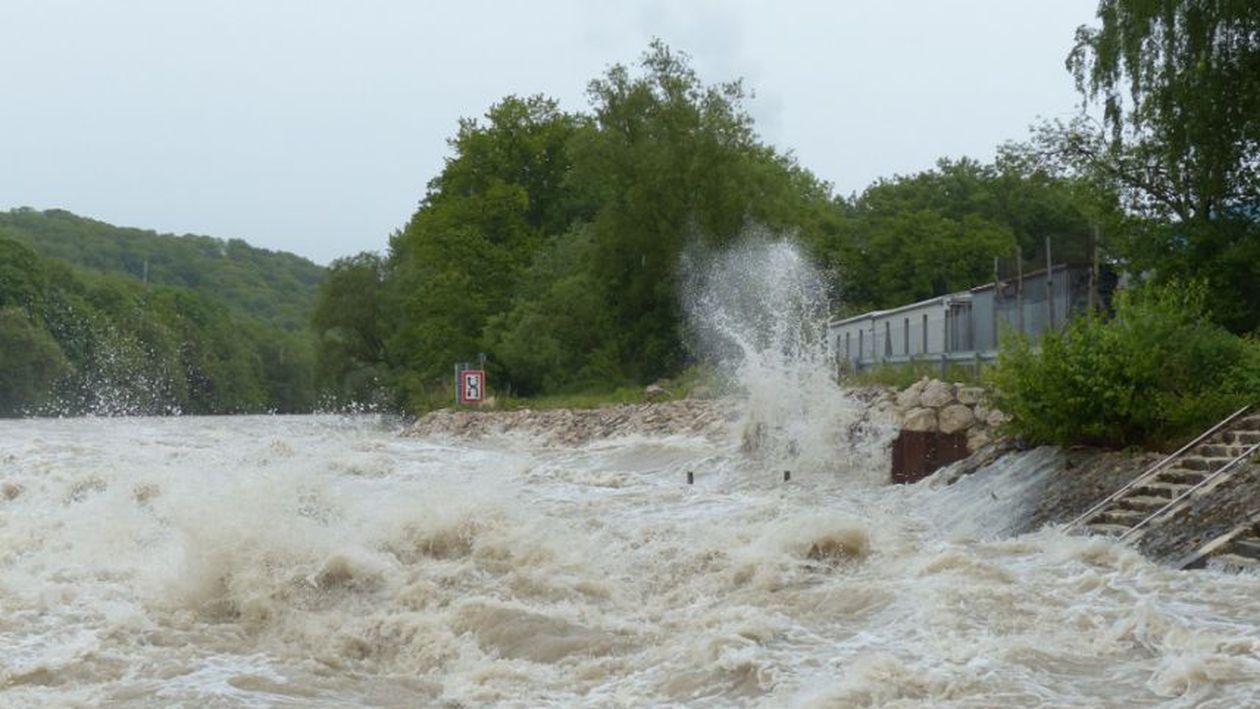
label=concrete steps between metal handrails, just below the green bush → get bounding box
[1067,407,1260,544]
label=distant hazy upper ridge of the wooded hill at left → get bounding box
[0,209,324,331]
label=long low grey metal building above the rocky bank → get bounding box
[828,263,1097,372]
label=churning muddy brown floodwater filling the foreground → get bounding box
[0,417,1260,706]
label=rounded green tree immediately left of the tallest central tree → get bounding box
[382,97,581,406]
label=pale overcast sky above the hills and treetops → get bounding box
[0,0,1096,263]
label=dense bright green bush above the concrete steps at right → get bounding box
[990,283,1260,446]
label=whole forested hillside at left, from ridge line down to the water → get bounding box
[0,209,323,416]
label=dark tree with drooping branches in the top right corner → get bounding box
[1063,0,1260,332]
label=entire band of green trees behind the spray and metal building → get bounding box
[315,43,1116,409]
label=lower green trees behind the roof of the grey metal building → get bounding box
[830,156,1118,310]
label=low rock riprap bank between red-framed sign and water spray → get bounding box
[410,399,740,446]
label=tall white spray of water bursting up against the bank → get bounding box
[684,232,891,482]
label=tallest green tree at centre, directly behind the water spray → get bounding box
[572,40,827,383]
